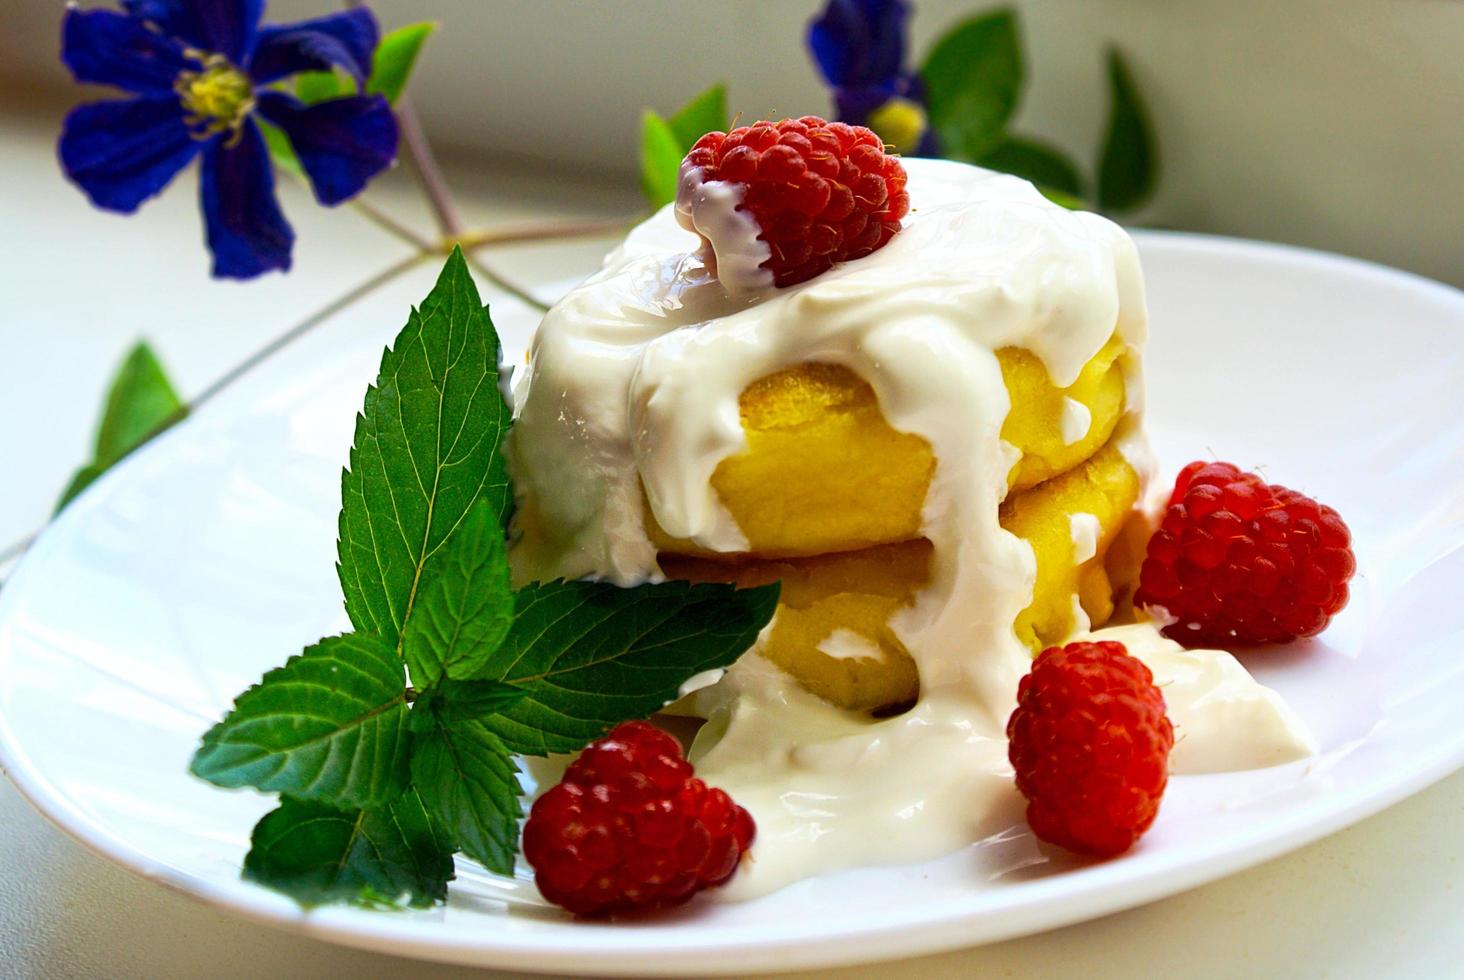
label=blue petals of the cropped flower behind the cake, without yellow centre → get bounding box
[808,0,909,88]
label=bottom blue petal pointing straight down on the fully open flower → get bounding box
[199,120,294,278]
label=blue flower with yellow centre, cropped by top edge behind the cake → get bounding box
[808,0,935,157]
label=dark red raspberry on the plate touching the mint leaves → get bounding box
[524,721,755,917]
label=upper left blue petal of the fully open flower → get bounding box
[61,7,192,95]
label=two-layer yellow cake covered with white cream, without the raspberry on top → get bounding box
[514,160,1148,715]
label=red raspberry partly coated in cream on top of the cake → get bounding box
[685,116,911,286]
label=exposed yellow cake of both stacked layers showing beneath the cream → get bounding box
[647,337,1139,712]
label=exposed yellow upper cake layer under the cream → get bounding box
[646,337,1124,558]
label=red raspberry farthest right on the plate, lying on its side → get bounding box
[1135,461,1357,645]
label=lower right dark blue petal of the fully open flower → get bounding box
[259,91,397,205]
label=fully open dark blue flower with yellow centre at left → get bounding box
[60,0,397,278]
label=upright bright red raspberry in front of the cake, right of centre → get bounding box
[1007,643,1174,857]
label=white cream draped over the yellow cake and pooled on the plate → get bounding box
[511,160,1304,897]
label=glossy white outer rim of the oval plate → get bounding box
[0,230,1464,974]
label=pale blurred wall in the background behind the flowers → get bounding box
[0,0,1464,284]
